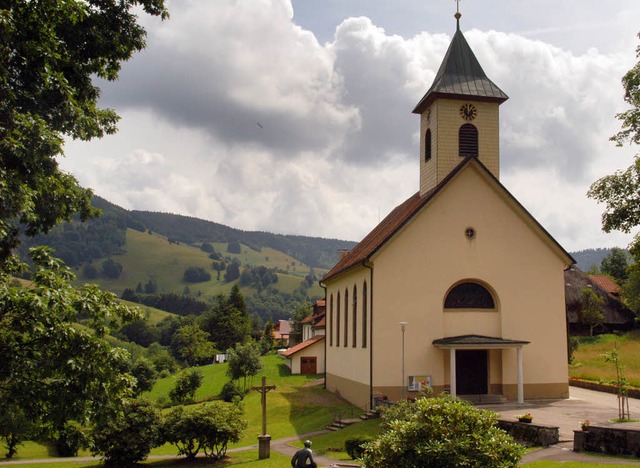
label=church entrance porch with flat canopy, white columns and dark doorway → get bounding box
[433,335,529,403]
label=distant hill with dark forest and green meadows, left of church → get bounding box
[19,197,355,320]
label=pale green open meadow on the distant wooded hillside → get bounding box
[78,229,323,300]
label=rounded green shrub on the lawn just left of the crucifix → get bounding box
[163,401,247,460]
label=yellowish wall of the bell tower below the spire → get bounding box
[420,99,500,194]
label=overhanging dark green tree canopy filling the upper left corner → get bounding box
[0,0,168,262]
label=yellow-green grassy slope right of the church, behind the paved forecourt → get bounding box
[569,330,640,388]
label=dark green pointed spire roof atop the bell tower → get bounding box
[413,28,509,114]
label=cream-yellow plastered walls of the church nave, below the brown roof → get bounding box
[327,162,568,410]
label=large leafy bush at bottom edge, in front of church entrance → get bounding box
[362,396,524,468]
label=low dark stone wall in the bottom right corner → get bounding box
[573,426,640,457]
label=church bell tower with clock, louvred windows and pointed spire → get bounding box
[413,12,509,195]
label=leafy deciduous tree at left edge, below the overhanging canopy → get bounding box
[0,248,140,436]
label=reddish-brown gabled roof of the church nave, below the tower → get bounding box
[321,157,575,283]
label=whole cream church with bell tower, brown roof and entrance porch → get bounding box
[321,13,575,409]
